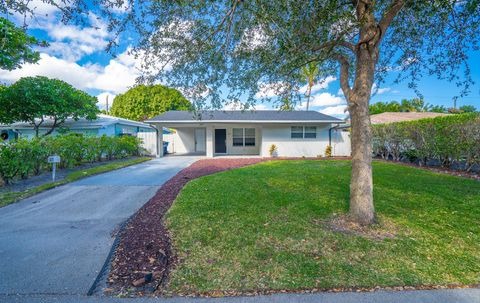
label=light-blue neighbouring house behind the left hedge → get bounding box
[0,115,155,140]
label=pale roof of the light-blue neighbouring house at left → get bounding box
[0,114,152,129]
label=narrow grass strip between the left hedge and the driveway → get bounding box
[0,157,151,207]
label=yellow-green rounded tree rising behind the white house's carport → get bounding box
[110,84,192,121]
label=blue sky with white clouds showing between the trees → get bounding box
[0,0,480,116]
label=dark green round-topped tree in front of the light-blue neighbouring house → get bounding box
[0,76,98,136]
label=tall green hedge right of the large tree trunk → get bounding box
[372,113,480,171]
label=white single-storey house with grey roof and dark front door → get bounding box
[145,110,350,157]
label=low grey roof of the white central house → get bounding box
[145,110,343,123]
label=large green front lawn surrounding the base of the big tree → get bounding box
[167,160,480,293]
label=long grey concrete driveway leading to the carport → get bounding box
[0,157,199,295]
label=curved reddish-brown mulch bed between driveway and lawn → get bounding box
[107,158,266,294]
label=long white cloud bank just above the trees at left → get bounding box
[0,51,140,94]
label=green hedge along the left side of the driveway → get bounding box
[0,134,141,184]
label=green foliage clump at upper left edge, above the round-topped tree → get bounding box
[0,17,47,70]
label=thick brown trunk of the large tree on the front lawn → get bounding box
[349,49,375,225]
